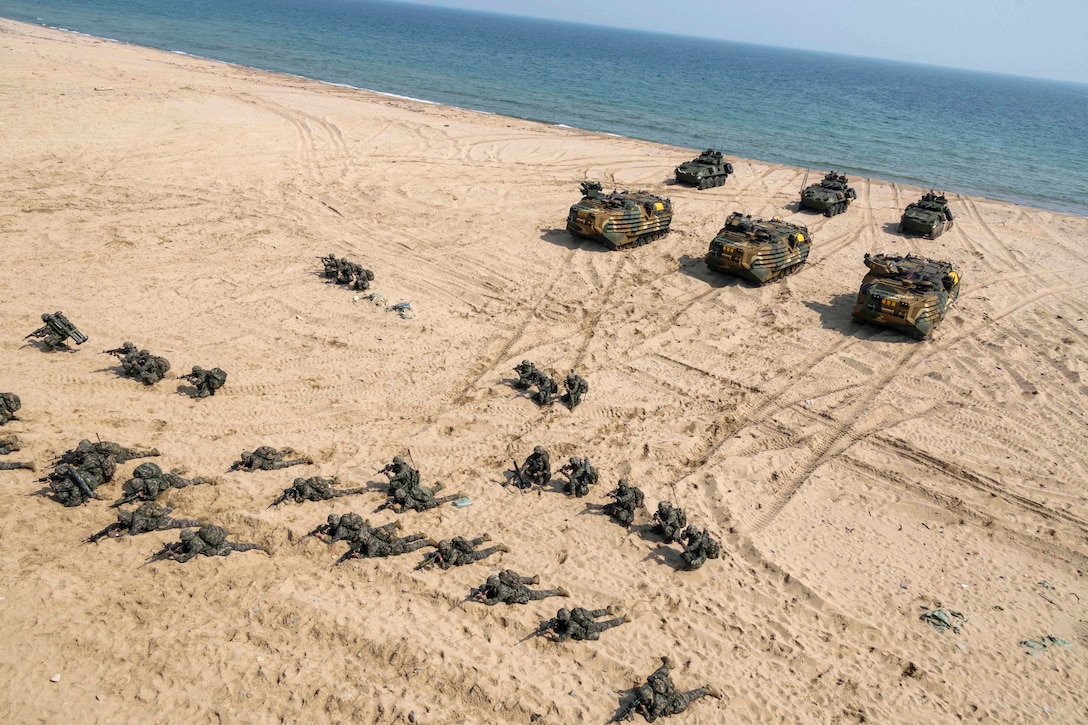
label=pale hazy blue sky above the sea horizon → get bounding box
[391,0,1088,83]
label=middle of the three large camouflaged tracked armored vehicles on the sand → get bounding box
[705,211,813,284]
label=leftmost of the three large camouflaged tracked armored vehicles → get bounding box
[567,182,672,249]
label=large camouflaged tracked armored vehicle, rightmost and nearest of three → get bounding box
[851,254,960,340]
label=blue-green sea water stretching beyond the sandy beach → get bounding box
[6,0,1088,216]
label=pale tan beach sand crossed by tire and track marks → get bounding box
[0,21,1088,724]
